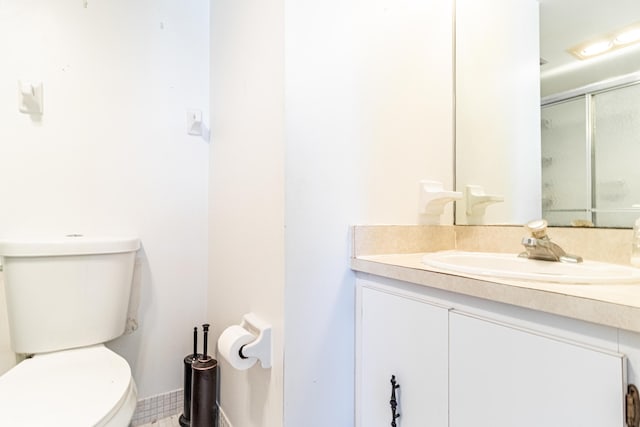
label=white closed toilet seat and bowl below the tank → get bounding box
[0,344,137,427]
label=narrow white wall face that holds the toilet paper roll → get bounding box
[208,0,285,427]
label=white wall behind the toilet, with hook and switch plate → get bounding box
[0,0,209,398]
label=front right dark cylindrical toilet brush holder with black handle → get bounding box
[190,324,218,427]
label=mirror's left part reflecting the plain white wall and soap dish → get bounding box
[455,0,541,225]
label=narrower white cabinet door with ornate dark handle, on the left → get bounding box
[357,287,448,427]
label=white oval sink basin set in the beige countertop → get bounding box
[422,251,640,284]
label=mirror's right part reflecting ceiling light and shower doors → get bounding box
[540,0,640,228]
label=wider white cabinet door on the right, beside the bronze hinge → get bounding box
[449,312,626,427]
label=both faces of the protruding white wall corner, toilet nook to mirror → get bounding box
[209,0,453,427]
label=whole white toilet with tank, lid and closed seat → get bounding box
[0,235,140,427]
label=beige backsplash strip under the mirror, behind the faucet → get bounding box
[352,225,632,265]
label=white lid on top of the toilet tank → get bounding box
[0,234,140,257]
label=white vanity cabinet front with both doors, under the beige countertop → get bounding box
[356,276,627,427]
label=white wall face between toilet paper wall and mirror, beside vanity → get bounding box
[284,0,453,427]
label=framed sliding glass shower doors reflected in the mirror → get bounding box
[542,83,640,228]
